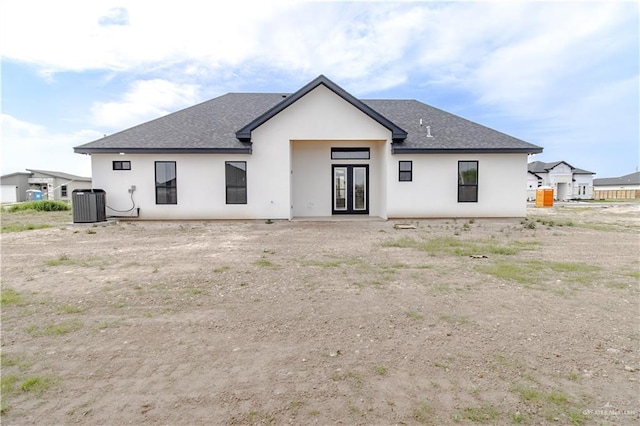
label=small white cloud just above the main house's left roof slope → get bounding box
[91,79,198,130]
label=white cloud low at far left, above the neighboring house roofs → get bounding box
[0,114,102,176]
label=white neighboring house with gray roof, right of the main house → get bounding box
[527,161,595,200]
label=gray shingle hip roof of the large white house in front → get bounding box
[74,76,542,154]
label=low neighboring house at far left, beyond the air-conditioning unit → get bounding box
[0,169,91,203]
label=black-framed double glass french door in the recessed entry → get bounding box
[332,164,369,214]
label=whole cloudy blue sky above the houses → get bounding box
[0,0,640,177]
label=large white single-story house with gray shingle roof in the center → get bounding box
[74,75,542,219]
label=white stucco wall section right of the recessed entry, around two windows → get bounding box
[387,154,527,218]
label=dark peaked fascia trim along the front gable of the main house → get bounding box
[236,75,407,141]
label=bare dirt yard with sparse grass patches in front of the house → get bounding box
[1,204,640,425]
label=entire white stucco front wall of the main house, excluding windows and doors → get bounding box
[91,85,527,220]
